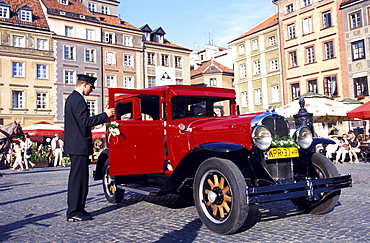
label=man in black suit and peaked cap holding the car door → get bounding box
[64,74,114,222]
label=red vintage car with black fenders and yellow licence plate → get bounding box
[94,86,352,234]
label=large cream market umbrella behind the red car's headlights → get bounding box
[276,92,360,123]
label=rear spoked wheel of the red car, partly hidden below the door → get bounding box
[103,161,125,203]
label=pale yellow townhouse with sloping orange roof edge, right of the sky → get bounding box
[230,14,283,113]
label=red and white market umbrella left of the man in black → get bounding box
[22,121,64,142]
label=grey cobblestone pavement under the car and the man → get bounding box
[0,163,370,242]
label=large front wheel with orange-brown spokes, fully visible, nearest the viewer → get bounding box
[194,158,249,234]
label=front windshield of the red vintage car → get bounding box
[171,96,230,120]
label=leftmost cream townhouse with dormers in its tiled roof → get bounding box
[0,0,56,126]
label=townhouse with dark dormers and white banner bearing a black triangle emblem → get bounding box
[140,24,191,88]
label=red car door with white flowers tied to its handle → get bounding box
[107,88,164,175]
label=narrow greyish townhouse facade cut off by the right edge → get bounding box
[340,0,370,101]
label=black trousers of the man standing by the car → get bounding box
[67,154,89,217]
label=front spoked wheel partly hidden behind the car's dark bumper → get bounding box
[291,153,341,214]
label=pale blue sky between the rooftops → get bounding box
[118,0,277,50]
